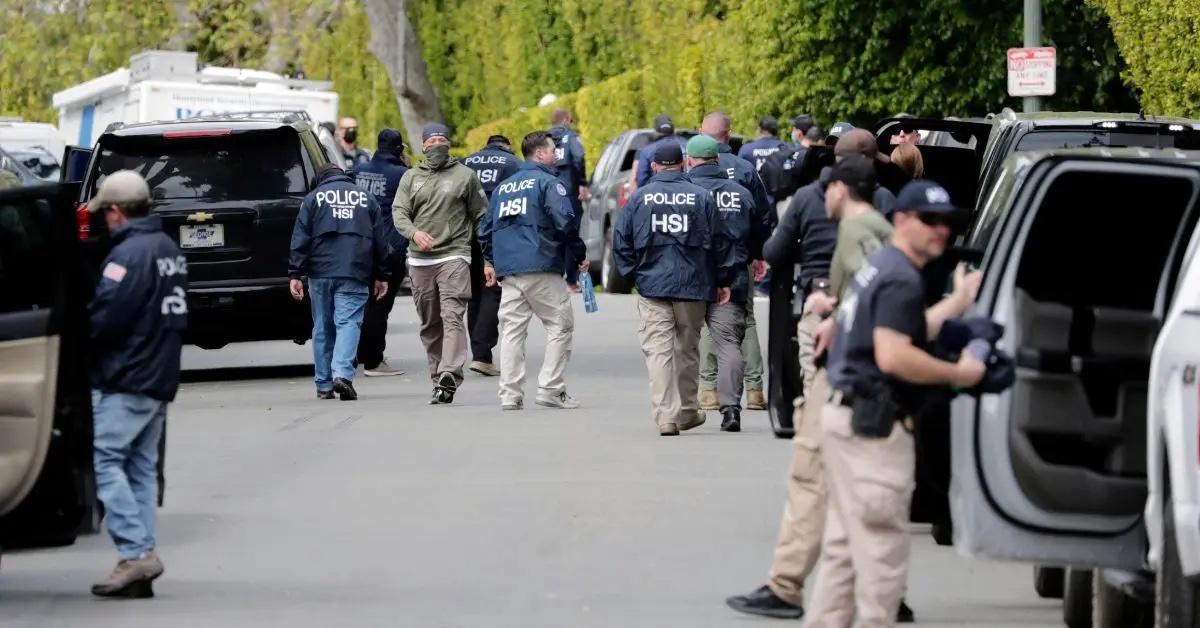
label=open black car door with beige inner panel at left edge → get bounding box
[0,185,95,546]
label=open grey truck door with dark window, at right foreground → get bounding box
[950,152,1200,570]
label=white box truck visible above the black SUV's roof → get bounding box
[53,50,337,146]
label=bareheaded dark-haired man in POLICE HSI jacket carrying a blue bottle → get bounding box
[479,131,588,409]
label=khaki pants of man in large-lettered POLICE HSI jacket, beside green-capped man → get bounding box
[637,295,708,425]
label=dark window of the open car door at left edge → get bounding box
[0,198,55,313]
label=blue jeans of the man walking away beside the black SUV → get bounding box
[308,277,371,391]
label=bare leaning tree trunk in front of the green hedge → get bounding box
[362,0,443,152]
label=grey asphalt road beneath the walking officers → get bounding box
[0,295,1061,628]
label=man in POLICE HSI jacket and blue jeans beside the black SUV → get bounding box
[288,163,391,401]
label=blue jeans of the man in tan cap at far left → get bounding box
[91,389,167,561]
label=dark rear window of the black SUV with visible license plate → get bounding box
[91,128,307,199]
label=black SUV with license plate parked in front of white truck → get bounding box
[77,112,329,348]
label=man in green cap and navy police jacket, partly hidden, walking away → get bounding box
[688,136,769,432]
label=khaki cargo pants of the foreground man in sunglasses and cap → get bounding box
[805,402,916,628]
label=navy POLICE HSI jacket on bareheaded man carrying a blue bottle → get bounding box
[479,161,587,277]
